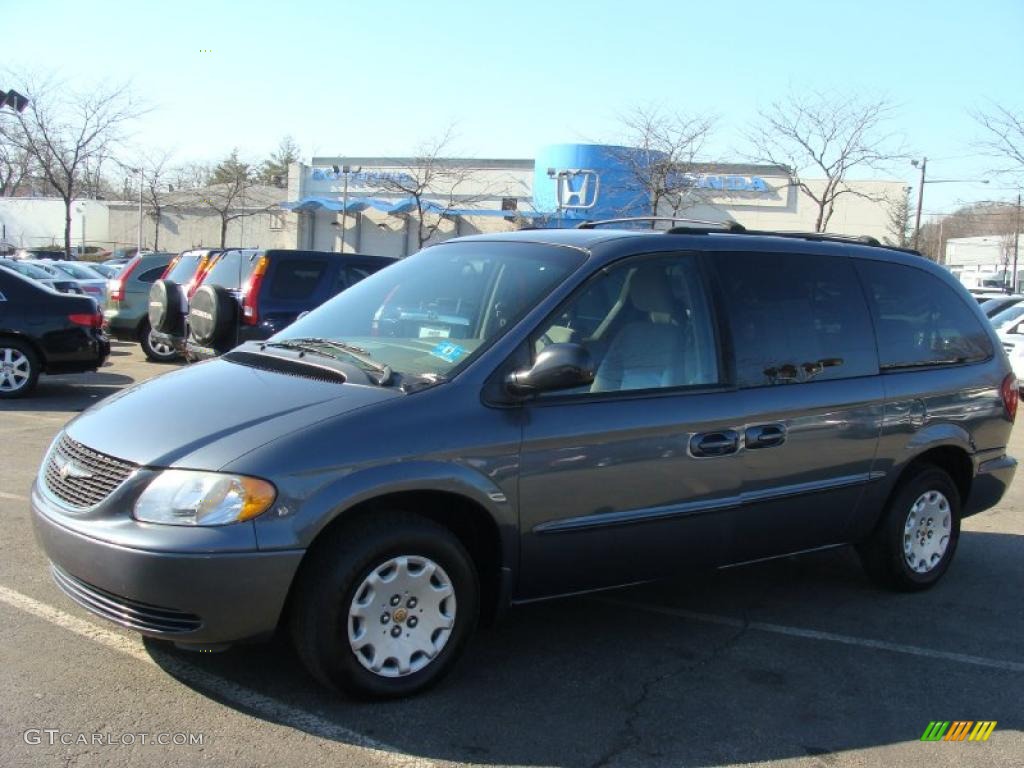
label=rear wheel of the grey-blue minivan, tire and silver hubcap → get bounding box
[857,464,961,592]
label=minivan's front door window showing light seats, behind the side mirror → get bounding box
[534,254,720,395]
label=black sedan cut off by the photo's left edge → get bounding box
[0,268,111,399]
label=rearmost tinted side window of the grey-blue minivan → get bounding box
[857,261,992,369]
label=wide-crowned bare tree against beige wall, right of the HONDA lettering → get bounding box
[746,92,905,232]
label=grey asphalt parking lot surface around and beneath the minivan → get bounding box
[0,343,1024,768]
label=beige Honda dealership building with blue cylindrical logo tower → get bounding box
[282,144,906,256]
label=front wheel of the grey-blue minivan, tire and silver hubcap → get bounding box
[291,512,479,698]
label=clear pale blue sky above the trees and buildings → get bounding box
[0,0,1024,215]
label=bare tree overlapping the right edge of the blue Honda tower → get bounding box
[617,106,715,216]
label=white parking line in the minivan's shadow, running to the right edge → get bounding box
[592,598,1024,672]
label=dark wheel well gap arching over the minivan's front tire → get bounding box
[296,490,502,624]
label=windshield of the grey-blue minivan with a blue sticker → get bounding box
[269,242,586,377]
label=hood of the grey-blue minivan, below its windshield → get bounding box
[67,359,403,470]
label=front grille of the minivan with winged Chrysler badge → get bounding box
[45,434,137,509]
